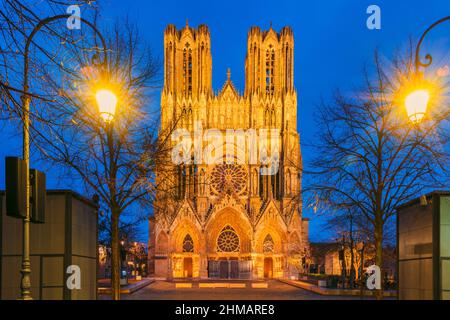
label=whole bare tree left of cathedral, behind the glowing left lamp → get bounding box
[25,22,163,299]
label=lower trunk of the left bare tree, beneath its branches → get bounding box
[111,209,121,300]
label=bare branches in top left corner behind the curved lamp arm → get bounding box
[0,0,98,112]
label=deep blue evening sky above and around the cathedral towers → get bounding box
[0,0,450,241]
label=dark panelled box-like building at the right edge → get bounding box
[397,191,450,300]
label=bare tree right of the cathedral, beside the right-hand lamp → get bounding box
[308,53,449,298]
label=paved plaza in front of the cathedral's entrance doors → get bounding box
[99,280,368,300]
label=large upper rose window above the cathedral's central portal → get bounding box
[211,164,247,194]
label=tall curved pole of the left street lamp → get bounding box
[20,14,108,300]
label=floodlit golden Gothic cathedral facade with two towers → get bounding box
[149,24,309,279]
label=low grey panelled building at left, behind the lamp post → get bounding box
[0,190,98,300]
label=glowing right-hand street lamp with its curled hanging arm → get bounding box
[405,16,450,123]
